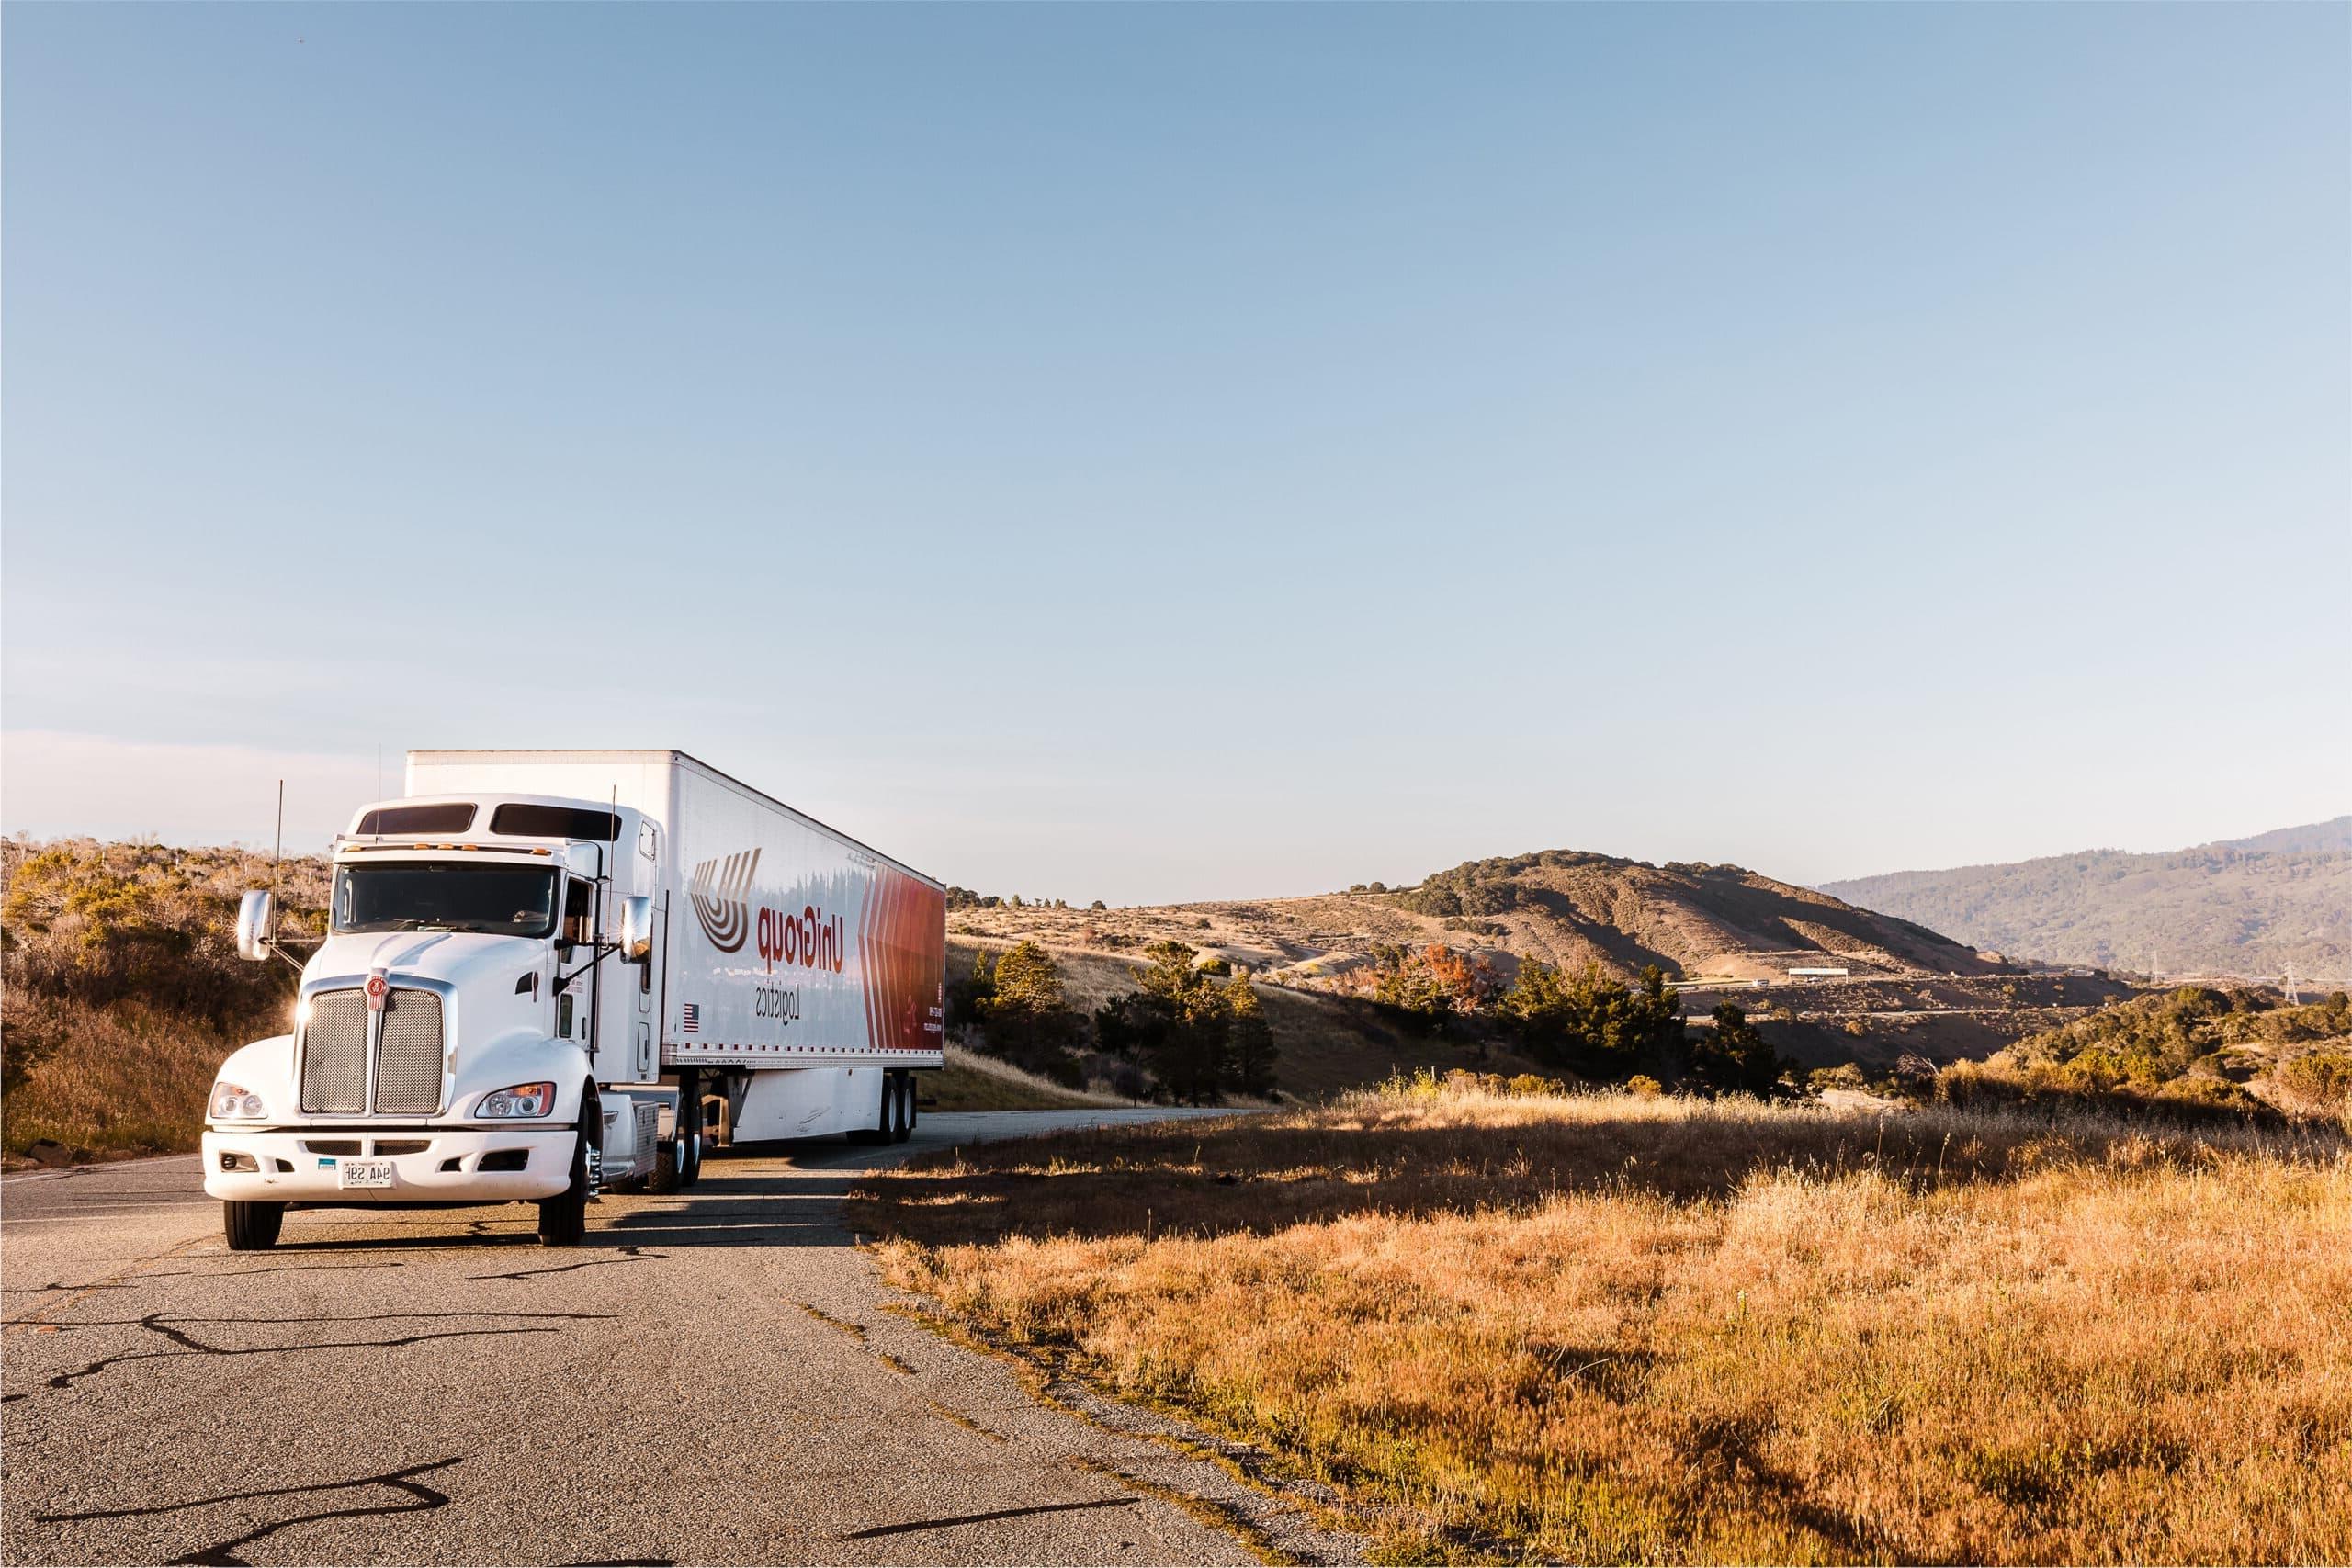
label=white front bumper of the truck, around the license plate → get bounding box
[205,1126,579,1206]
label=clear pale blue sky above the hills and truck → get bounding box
[0,3,2352,903]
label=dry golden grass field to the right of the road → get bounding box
[856,1093,2352,1561]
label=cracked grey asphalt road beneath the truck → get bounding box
[0,1110,1312,1563]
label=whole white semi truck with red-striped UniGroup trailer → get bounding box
[205,752,948,1251]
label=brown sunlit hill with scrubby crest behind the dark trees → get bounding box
[948,849,2126,1081]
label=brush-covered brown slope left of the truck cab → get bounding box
[0,840,327,1159]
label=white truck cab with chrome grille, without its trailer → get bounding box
[202,795,701,1251]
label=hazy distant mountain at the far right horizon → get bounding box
[1820,816,2352,978]
